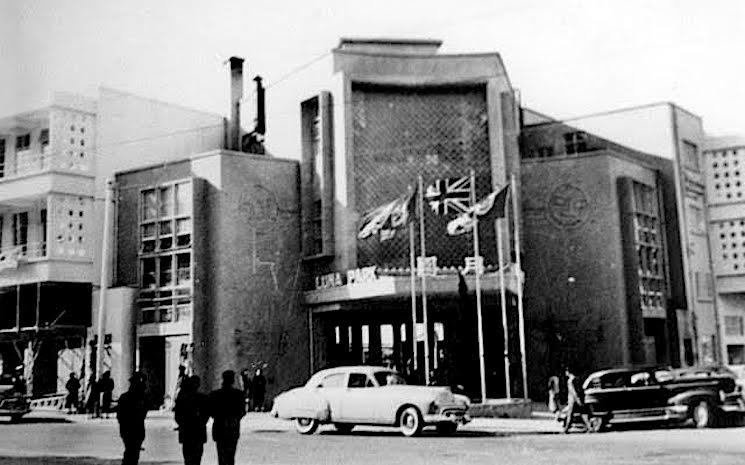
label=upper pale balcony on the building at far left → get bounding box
[0,150,95,204]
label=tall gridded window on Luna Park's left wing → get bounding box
[139,181,192,323]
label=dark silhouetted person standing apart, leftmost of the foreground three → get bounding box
[116,371,147,465]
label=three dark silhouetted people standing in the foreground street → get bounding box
[117,370,246,465]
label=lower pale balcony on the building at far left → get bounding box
[0,241,93,287]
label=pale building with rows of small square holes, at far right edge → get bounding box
[703,137,745,365]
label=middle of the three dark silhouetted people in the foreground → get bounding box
[174,376,210,465]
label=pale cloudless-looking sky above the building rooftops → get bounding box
[0,0,745,138]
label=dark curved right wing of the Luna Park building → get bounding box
[520,116,684,398]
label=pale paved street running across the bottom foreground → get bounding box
[0,414,745,465]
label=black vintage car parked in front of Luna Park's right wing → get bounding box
[583,367,745,430]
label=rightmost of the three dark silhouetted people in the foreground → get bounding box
[209,370,246,465]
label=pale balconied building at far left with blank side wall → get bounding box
[0,89,224,395]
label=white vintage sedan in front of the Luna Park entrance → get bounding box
[272,366,470,436]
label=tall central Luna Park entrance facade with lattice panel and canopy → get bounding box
[300,39,520,397]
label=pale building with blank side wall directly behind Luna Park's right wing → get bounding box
[552,102,723,365]
